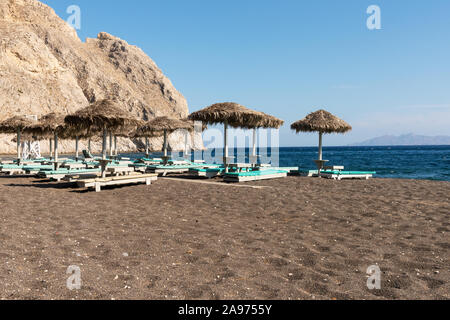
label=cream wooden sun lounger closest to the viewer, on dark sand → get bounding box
[77,174,158,192]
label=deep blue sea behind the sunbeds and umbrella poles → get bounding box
[129,146,450,181]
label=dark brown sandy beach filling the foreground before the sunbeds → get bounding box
[0,177,450,300]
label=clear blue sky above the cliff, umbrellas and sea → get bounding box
[43,0,450,146]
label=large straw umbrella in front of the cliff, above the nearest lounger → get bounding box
[65,99,141,176]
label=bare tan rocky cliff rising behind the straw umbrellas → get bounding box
[0,0,201,154]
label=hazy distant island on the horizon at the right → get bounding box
[351,133,450,146]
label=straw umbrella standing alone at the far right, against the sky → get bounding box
[291,110,352,170]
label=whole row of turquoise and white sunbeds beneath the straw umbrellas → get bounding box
[0,151,375,190]
